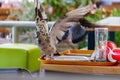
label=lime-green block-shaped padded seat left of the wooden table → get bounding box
[0,43,41,72]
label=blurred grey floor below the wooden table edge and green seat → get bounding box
[0,70,120,80]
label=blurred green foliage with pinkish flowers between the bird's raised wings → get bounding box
[42,0,94,21]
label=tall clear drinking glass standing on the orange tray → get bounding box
[95,28,108,61]
